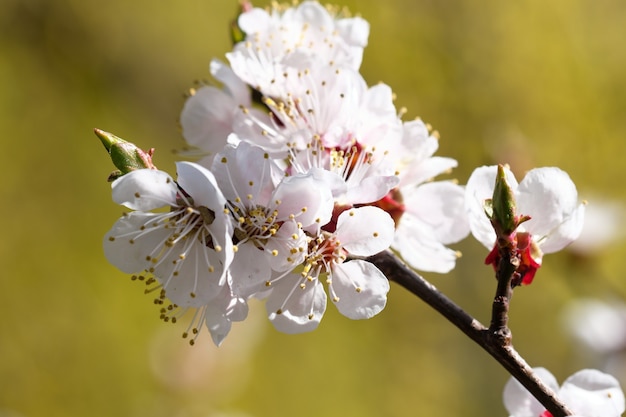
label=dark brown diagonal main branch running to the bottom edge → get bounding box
[367,251,573,417]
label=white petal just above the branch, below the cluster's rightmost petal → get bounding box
[391,228,459,274]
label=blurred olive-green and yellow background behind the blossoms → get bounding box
[0,0,626,417]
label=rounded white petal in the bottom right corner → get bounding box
[559,369,625,417]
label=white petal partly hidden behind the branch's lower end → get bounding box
[503,368,559,417]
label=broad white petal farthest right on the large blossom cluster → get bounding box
[398,181,469,244]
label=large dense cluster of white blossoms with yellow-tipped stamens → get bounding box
[104,2,469,344]
